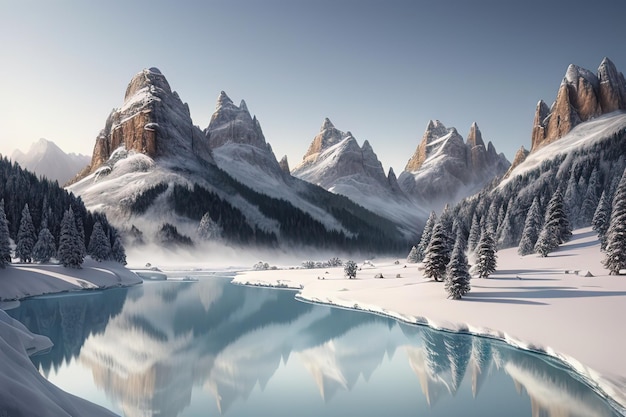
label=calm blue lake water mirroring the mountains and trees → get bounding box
[10,278,617,417]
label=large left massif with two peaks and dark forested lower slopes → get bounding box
[69,68,405,249]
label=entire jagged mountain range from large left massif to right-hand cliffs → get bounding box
[56,59,626,249]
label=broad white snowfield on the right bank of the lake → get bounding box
[233,228,626,413]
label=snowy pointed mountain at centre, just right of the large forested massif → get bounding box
[291,118,427,236]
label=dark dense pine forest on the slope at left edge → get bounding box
[0,158,126,267]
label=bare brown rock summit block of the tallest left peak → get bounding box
[75,68,212,180]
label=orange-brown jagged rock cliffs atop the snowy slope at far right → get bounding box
[530,58,626,152]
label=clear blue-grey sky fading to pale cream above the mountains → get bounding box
[0,0,626,174]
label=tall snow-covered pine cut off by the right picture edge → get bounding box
[603,170,626,275]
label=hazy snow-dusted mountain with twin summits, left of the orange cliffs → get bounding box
[398,120,510,209]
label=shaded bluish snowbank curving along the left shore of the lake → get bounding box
[0,259,142,417]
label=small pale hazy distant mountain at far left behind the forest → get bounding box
[10,138,90,185]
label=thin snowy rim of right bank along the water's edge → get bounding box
[231,272,626,416]
